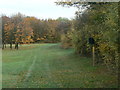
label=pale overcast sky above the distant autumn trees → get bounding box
[0,0,77,19]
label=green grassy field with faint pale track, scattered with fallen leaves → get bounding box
[2,44,117,88]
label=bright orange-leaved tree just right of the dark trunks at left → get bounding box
[15,18,33,43]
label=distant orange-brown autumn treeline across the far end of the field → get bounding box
[2,13,71,49]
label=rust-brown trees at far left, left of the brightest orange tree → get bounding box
[2,13,24,49]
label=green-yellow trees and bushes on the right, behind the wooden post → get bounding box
[62,3,119,71]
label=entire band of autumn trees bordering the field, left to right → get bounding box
[2,2,120,71]
